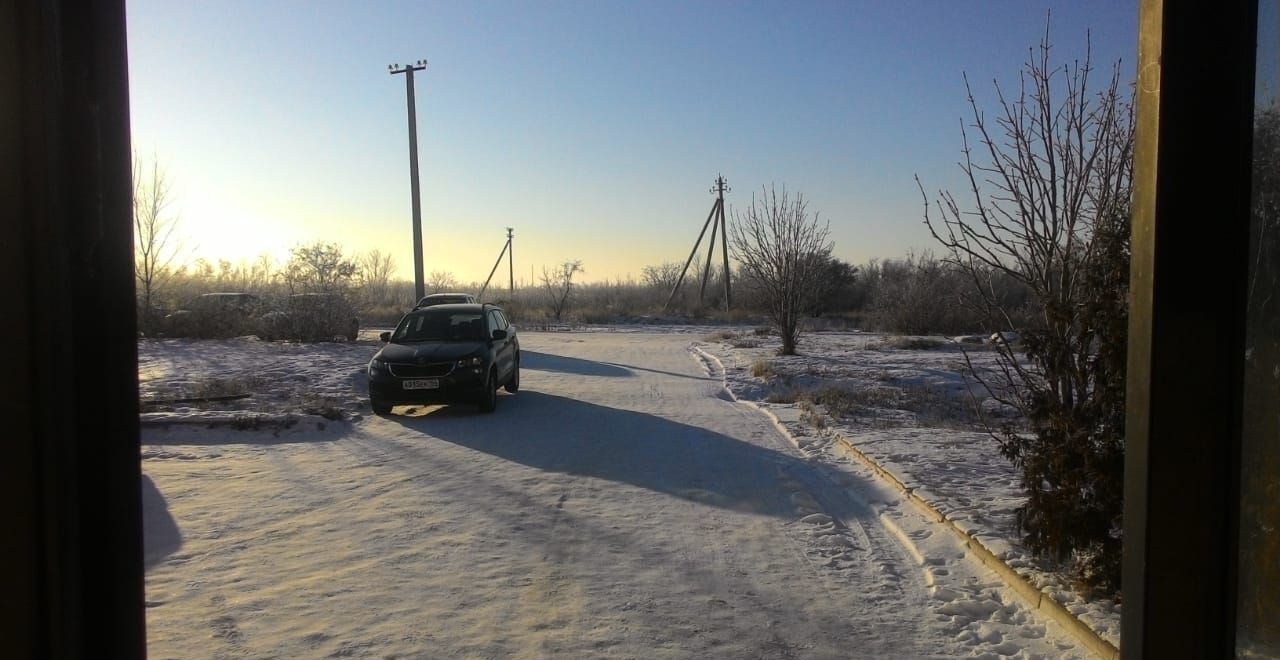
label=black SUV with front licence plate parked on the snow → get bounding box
[369,304,520,414]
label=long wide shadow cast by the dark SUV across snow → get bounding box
[385,390,873,519]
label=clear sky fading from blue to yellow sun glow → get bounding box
[128,0,1138,280]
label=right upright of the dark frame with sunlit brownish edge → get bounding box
[1121,0,1257,657]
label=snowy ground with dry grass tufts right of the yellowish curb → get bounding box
[701,330,1120,646]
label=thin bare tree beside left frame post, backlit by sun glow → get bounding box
[133,155,182,334]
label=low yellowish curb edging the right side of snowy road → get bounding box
[690,344,1120,660]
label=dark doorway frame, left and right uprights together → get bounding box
[0,0,1257,657]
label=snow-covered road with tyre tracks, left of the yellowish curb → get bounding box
[143,333,1079,659]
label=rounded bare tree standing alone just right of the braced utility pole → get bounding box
[730,187,832,356]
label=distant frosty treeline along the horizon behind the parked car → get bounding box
[147,243,1029,335]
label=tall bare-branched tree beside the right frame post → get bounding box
[916,29,1133,586]
